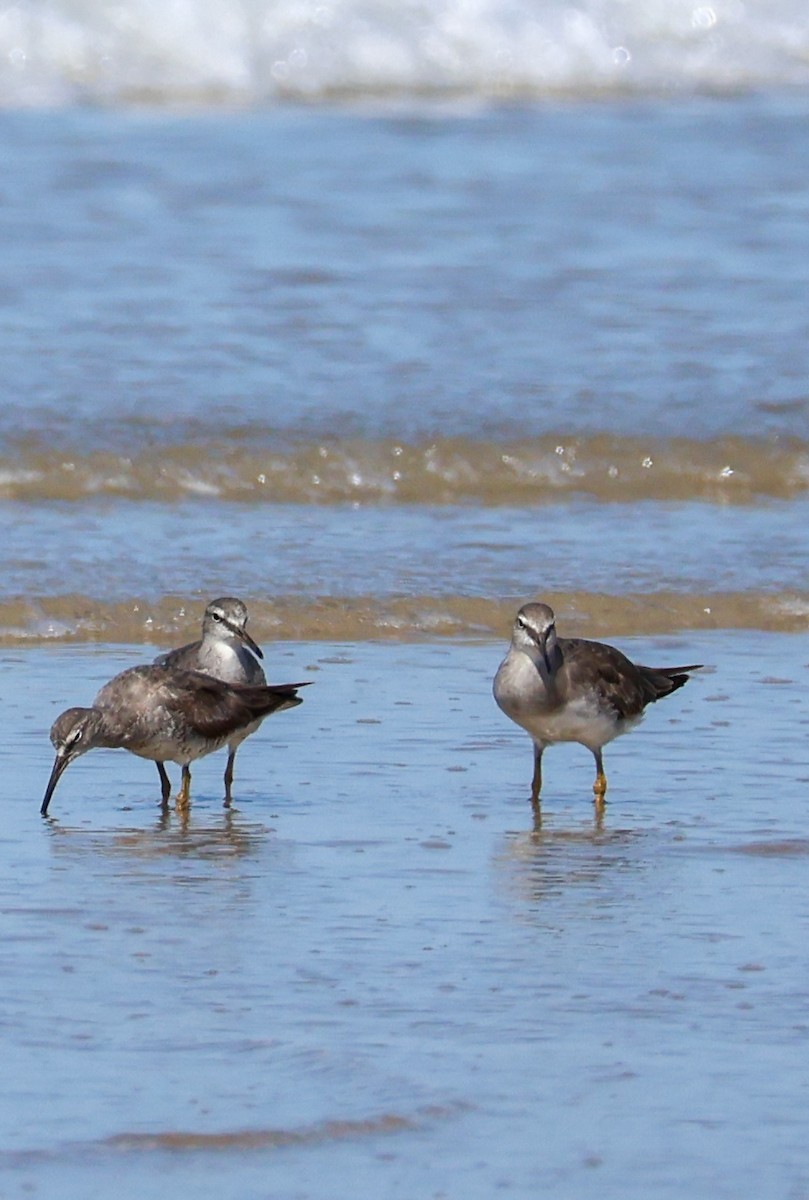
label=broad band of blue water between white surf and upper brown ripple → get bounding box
[0,94,809,450]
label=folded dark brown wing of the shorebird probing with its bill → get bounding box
[166,671,306,738]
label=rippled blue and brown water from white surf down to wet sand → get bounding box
[0,91,809,643]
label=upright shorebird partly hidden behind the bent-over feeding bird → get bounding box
[155,596,266,809]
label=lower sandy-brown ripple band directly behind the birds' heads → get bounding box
[0,592,809,653]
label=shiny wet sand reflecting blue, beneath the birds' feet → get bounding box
[0,631,809,1200]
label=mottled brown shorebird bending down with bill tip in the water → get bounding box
[40,665,306,816]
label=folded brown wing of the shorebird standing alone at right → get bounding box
[558,637,660,720]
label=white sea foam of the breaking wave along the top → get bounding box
[0,0,809,107]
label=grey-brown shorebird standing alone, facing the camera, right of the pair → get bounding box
[493,604,701,808]
